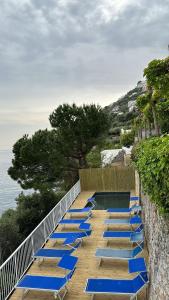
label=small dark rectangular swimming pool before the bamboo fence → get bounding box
[87,192,130,210]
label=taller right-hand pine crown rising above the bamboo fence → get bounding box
[49,104,109,168]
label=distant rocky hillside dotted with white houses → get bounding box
[105,81,146,131]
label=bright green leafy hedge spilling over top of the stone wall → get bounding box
[132,135,169,214]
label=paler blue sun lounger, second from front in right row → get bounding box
[95,242,144,265]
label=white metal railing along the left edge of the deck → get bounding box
[0,180,81,300]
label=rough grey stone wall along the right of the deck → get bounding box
[142,194,169,300]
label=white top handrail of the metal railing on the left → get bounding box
[0,180,80,270]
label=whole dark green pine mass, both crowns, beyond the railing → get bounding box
[9,104,109,192]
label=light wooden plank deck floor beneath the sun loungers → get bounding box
[10,191,146,300]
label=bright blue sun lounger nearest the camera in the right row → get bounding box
[85,258,148,300]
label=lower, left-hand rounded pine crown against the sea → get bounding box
[8,129,65,191]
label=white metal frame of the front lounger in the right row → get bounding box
[84,272,149,300]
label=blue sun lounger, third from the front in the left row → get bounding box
[49,230,92,247]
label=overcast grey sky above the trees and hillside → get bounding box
[0,0,169,149]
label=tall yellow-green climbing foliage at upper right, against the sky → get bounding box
[135,57,169,136]
